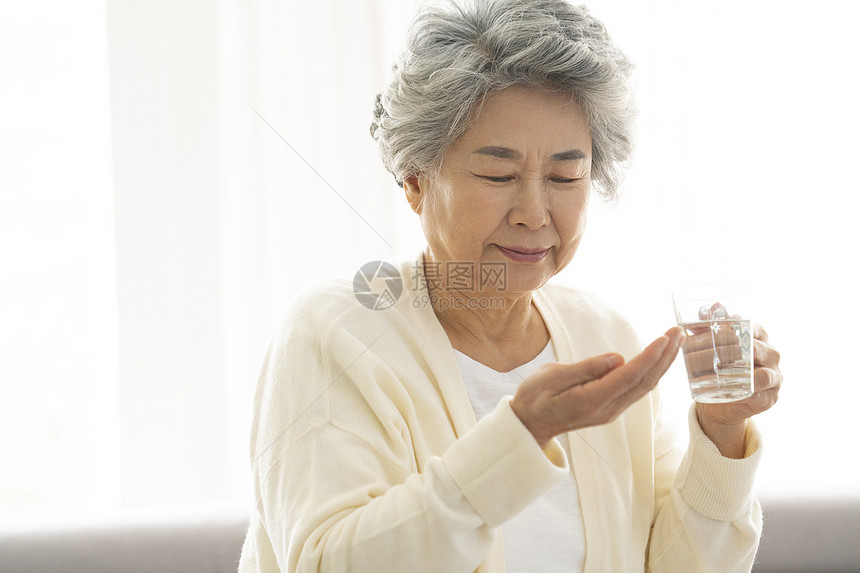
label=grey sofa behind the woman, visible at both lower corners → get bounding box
[0,497,860,573]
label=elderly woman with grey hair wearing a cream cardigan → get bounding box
[240,0,781,573]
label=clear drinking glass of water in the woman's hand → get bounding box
[672,283,754,403]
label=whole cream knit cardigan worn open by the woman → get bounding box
[239,257,761,573]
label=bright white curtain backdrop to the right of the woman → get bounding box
[568,0,860,496]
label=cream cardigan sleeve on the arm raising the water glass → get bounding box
[647,405,762,573]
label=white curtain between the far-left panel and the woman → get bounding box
[108,1,424,505]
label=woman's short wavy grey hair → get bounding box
[370,0,635,199]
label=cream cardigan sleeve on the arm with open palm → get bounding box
[240,298,569,573]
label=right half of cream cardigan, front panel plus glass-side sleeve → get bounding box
[539,287,761,573]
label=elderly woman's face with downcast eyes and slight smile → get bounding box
[404,86,591,293]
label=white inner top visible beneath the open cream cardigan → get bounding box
[454,342,585,573]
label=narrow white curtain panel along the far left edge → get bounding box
[0,1,120,524]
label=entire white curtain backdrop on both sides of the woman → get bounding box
[0,0,860,515]
